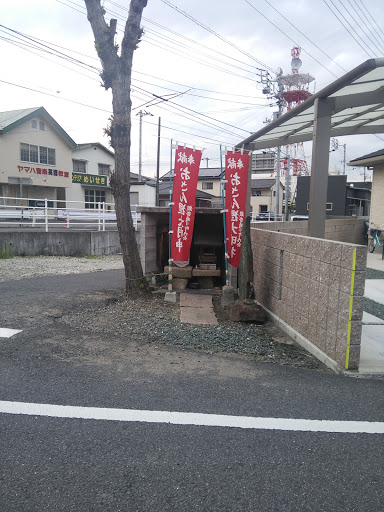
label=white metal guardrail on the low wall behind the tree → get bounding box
[0,196,141,232]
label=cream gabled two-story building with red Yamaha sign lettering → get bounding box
[0,107,76,206]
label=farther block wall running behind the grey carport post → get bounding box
[255,217,365,244]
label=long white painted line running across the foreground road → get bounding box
[0,401,384,434]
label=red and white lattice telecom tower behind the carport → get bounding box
[276,46,314,176]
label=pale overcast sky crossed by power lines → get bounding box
[0,0,384,178]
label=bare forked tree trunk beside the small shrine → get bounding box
[85,0,147,294]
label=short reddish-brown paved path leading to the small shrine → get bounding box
[180,293,218,325]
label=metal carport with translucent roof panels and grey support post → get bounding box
[236,58,384,238]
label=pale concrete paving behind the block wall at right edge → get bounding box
[359,249,384,374]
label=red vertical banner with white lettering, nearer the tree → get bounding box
[171,146,201,267]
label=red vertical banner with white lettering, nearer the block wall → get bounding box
[225,151,249,267]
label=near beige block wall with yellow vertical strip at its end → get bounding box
[251,228,367,369]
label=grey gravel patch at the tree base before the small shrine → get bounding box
[61,294,325,369]
